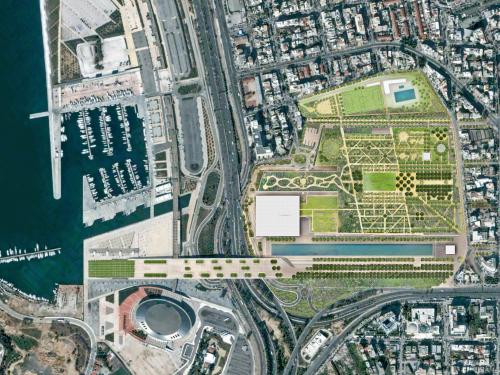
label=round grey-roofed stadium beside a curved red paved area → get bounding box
[135,296,196,341]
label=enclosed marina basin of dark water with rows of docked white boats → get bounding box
[62,104,149,203]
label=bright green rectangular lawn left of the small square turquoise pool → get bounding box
[341,85,384,115]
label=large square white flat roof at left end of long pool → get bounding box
[255,195,300,237]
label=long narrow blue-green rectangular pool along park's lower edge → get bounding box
[272,243,432,256]
